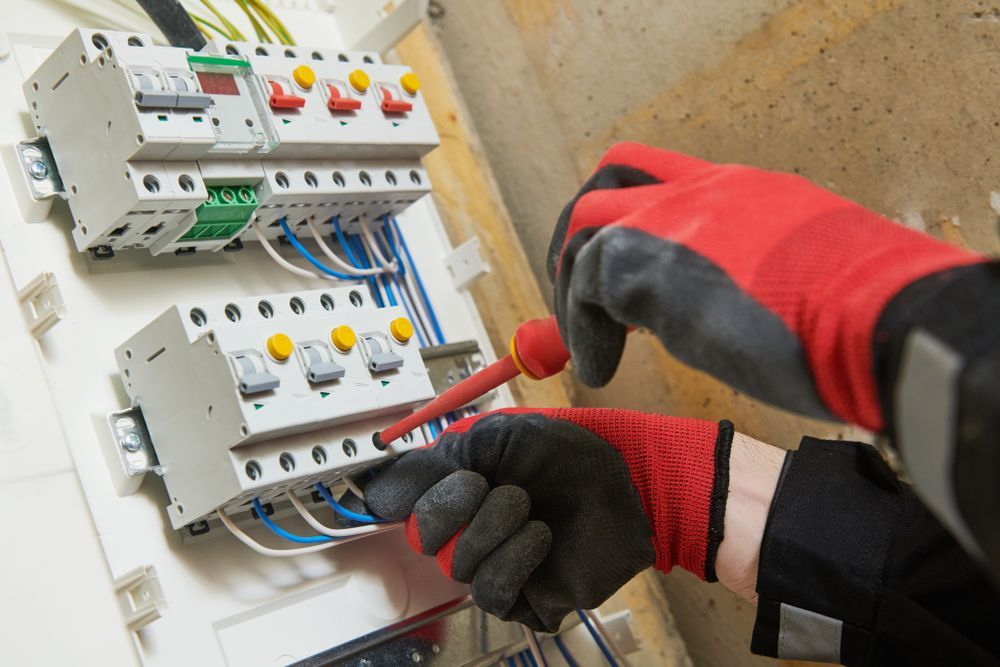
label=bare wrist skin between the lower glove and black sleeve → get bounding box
[715,433,785,602]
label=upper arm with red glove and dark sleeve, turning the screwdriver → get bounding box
[548,144,1000,581]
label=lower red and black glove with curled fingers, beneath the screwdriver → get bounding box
[365,409,733,632]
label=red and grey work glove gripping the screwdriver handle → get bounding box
[548,144,984,430]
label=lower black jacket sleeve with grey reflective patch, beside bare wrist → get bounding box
[751,438,1000,666]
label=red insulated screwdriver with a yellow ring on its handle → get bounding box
[372,315,569,449]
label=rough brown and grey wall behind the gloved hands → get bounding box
[436,0,1000,665]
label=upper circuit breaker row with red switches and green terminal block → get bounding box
[24,30,438,257]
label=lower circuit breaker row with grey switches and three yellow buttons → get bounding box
[115,287,434,528]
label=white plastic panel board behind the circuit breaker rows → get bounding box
[0,6,511,666]
